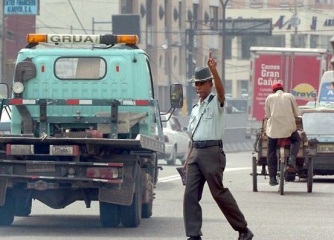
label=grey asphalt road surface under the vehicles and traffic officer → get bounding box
[0,152,334,240]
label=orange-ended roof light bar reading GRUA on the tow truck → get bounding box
[27,33,139,45]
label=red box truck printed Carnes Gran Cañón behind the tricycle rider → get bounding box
[246,47,332,138]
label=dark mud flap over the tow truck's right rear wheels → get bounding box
[99,166,138,206]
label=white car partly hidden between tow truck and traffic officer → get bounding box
[161,114,191,165]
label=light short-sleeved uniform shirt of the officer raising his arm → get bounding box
[188,93,225,141]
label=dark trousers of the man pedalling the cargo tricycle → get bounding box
[267,131,301,177]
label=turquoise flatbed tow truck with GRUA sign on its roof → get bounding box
[0,34,183,227]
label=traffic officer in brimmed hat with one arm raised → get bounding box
[183,53,254,240]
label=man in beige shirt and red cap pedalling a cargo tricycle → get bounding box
[265,82,301,186]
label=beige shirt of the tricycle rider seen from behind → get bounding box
[265,90,299,138]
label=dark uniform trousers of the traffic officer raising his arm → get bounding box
[183,146,247,236]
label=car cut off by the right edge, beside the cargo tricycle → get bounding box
[301,107,334,175]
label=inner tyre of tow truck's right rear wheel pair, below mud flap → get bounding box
[100,202,120,227]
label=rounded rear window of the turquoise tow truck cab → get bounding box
[55,57,107,80]
